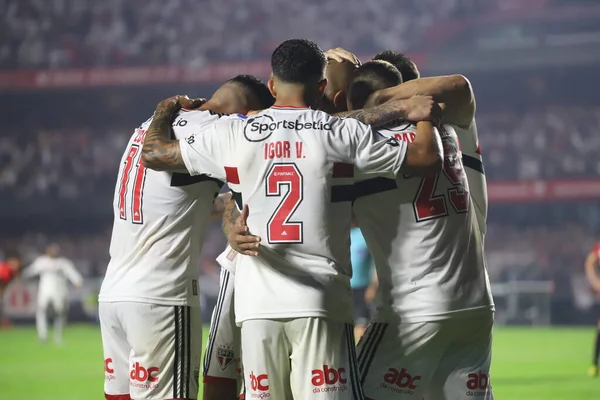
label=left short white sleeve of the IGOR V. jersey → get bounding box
[179,121,232,181]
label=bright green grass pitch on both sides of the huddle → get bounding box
[0,325,600,400]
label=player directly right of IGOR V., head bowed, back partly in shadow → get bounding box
[348,60,494,399]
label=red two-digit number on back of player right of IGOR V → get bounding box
[413,135,470,222]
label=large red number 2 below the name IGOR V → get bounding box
[265,163,304,244]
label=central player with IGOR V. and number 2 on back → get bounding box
[139,39,441,399]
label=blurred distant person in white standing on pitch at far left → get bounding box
[22,244,83,344]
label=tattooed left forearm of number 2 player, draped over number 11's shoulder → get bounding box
[142,110,185,171]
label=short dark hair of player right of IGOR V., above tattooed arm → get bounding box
[348,60,402,109]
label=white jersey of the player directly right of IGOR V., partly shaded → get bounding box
[354,124,493,322]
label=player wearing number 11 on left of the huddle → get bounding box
[98,75,273,400]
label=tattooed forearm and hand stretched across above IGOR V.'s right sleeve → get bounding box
[335,96,439,127]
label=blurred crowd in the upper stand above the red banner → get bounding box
[0,0,528,68]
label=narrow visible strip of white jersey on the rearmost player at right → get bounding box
[454,120,488,235]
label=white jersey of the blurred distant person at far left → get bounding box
[23,255,83,297]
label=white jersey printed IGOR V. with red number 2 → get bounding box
[180,107,407,323]
